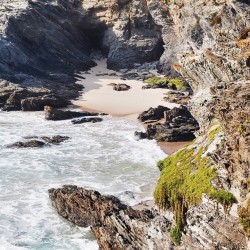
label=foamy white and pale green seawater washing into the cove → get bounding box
[0,112,165,250]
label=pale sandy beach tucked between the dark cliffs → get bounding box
[73,60,178,120]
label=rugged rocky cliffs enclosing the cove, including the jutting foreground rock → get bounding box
[0,0,250,250]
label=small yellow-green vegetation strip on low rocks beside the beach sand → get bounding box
[145,77,188,90]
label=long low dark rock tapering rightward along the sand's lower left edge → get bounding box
[44,106,98,121]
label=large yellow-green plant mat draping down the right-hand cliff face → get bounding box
[154,126,236,244]
